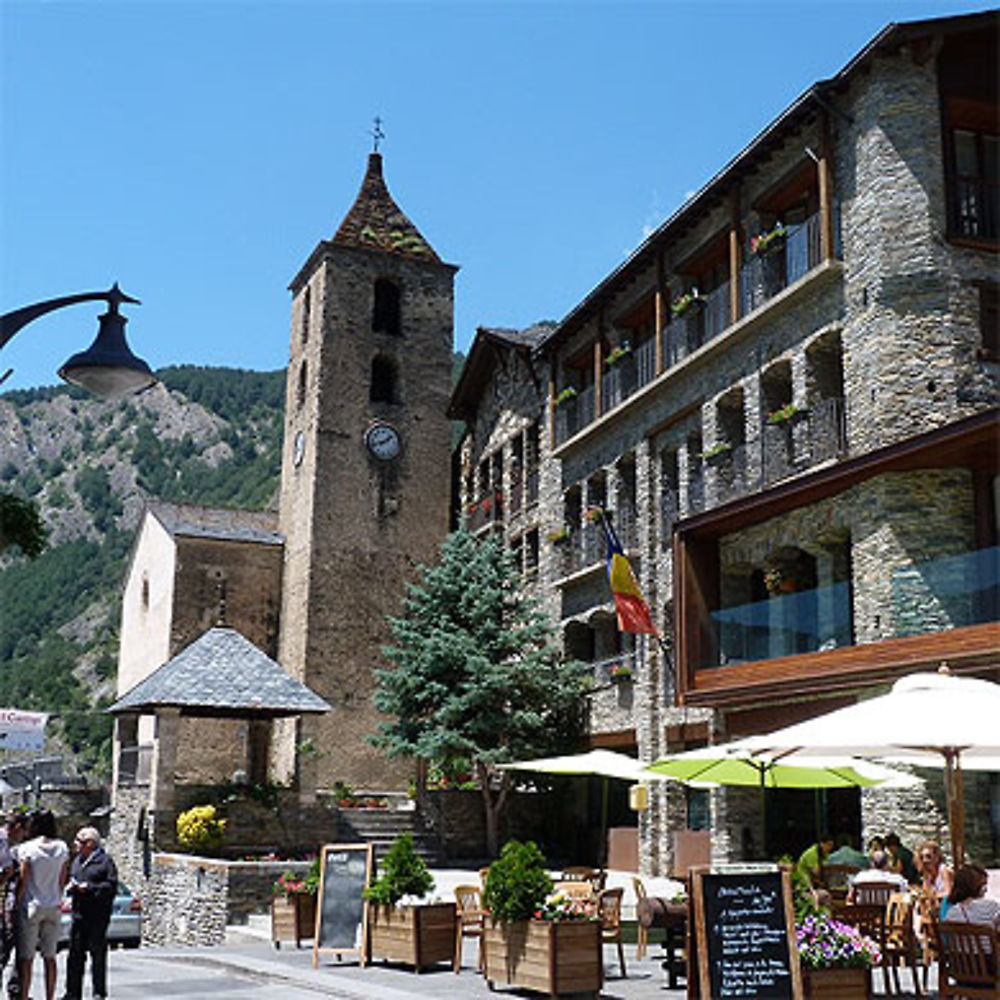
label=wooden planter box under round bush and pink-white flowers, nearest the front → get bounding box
[483,920,604,997]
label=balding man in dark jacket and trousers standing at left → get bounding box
[63,826,118,1000]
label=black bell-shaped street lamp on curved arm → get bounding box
[0,283,156,399]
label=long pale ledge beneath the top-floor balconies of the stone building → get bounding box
[551,259,844,458]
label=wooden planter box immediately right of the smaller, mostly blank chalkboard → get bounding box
[368,903,456,972]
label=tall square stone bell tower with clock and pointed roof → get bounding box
[272,152,458,797]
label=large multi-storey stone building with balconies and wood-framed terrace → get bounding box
[452,12,1000,871]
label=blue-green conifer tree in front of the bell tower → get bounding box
[373,529,585,856]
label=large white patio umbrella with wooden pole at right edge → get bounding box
[746,668,1000,864]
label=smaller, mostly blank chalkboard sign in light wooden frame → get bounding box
[313,844,374,968]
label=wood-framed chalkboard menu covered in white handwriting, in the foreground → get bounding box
[692,866,802,1000]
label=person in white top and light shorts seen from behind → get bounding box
[17,809,69,1000]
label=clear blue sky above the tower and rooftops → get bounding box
[0,0,987,389]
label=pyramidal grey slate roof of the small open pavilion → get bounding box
[108,625,330,718]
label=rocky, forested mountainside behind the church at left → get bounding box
[0,367,285,768]
